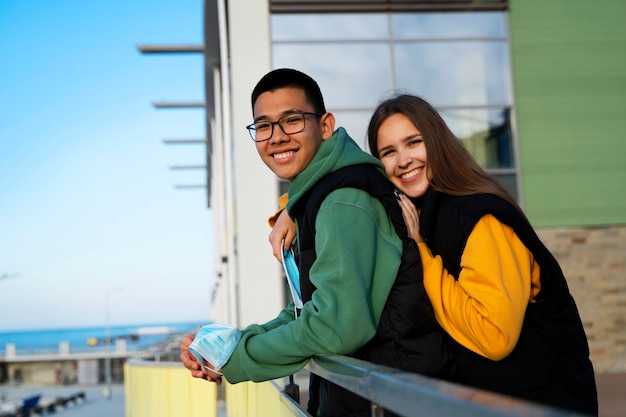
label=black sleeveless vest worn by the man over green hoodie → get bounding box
[292,165,451,416]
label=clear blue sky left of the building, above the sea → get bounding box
[0,0,213,331]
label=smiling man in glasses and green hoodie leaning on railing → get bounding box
[181,69,440,416]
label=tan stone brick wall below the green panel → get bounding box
[537,226,626,374]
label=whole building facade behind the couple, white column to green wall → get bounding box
[163,0,626,372]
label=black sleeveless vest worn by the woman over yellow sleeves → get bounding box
[420,190,598,415]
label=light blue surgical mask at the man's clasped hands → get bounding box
[189,323,241,371]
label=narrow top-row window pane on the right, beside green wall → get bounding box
[392,12,506,39]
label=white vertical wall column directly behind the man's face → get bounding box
[214,0,284,327]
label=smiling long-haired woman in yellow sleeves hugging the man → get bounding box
[360,94,598,415]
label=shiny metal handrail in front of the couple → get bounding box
[306,355,584,417]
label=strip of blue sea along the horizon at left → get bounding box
[0,322,205,355]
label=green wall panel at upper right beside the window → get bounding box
[509,0,626,227]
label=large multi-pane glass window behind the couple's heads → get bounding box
[271,11,519,197]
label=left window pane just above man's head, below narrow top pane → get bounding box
[272,43,392,109]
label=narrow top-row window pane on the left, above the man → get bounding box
[271,13,389,42]
